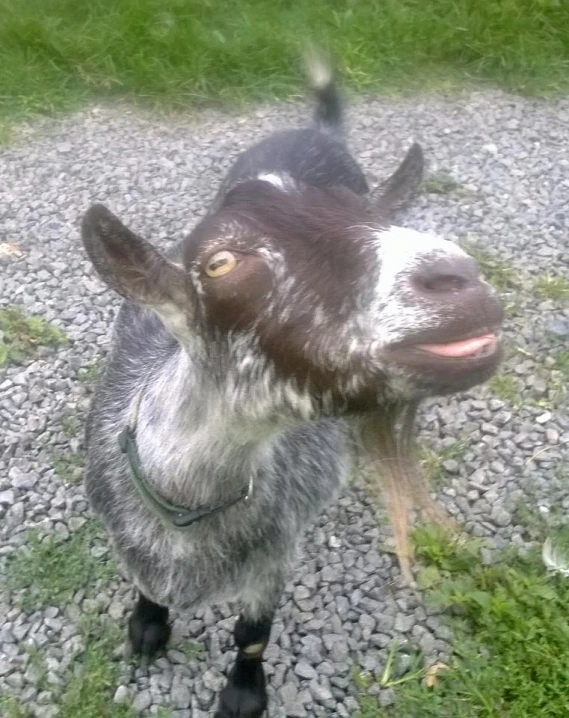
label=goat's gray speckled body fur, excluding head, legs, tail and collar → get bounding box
[86,109,367,618]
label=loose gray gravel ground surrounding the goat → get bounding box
[0,92,569,718]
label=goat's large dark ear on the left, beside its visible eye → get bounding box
[82,204,188,315]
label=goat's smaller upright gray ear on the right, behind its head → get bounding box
[370,142,425,222]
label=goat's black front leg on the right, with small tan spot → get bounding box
[215,612,273,718]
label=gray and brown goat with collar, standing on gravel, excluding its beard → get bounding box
[82,59,503,718]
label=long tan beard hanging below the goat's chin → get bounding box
[359,402,456,583]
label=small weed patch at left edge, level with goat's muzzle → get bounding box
[0,307,68,366]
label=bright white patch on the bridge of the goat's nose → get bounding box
[374,227,467,297]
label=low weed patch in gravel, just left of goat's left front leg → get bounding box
[6,519,115,611]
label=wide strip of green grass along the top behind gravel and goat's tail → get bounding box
[0,0,569,126]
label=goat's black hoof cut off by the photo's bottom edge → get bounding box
[215,659,268,718]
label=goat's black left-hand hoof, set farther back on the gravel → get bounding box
[128,596,172,664]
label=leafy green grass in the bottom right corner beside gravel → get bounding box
[358,529,569,718]
